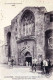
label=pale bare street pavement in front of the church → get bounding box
[0,64,53,80]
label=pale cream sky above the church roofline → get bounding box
[0,0,53,41]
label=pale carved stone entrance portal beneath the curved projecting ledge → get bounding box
[18,39,36,66]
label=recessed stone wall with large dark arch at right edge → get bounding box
[45,12,53,64]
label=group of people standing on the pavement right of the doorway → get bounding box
[32,60,51,73]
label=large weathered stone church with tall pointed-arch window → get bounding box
[4,7,53,66]
